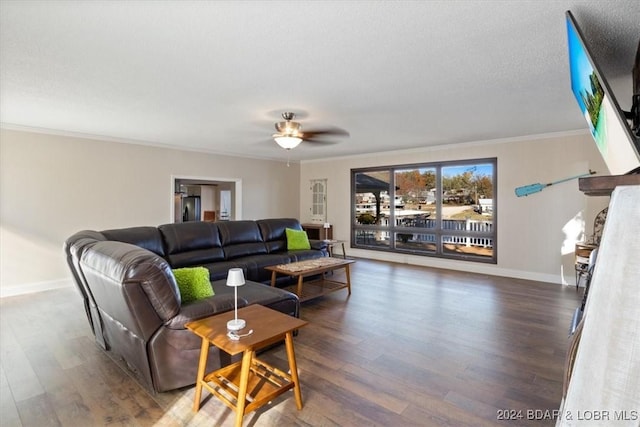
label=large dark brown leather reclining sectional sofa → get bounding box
[64,218,328,392]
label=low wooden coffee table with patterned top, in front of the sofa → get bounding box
[265,257,355,302]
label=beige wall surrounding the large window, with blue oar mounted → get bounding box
[300,132,609,284]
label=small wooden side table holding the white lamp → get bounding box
[185,305,308,427]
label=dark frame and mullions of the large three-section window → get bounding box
[350,157,498,264]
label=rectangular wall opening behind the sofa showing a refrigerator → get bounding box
[171,176,242,222]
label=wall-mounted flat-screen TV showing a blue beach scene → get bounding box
[566,11,640,175]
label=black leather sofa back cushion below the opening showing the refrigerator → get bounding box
[158,221,224,268]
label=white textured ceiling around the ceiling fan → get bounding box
[0,0,640,160]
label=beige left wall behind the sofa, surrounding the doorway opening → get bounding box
[0,129,300,296]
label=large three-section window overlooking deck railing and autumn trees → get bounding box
[351,159,497,263]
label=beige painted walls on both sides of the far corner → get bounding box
[0,129,609,295]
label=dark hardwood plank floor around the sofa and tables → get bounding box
[0,259,581,427]
